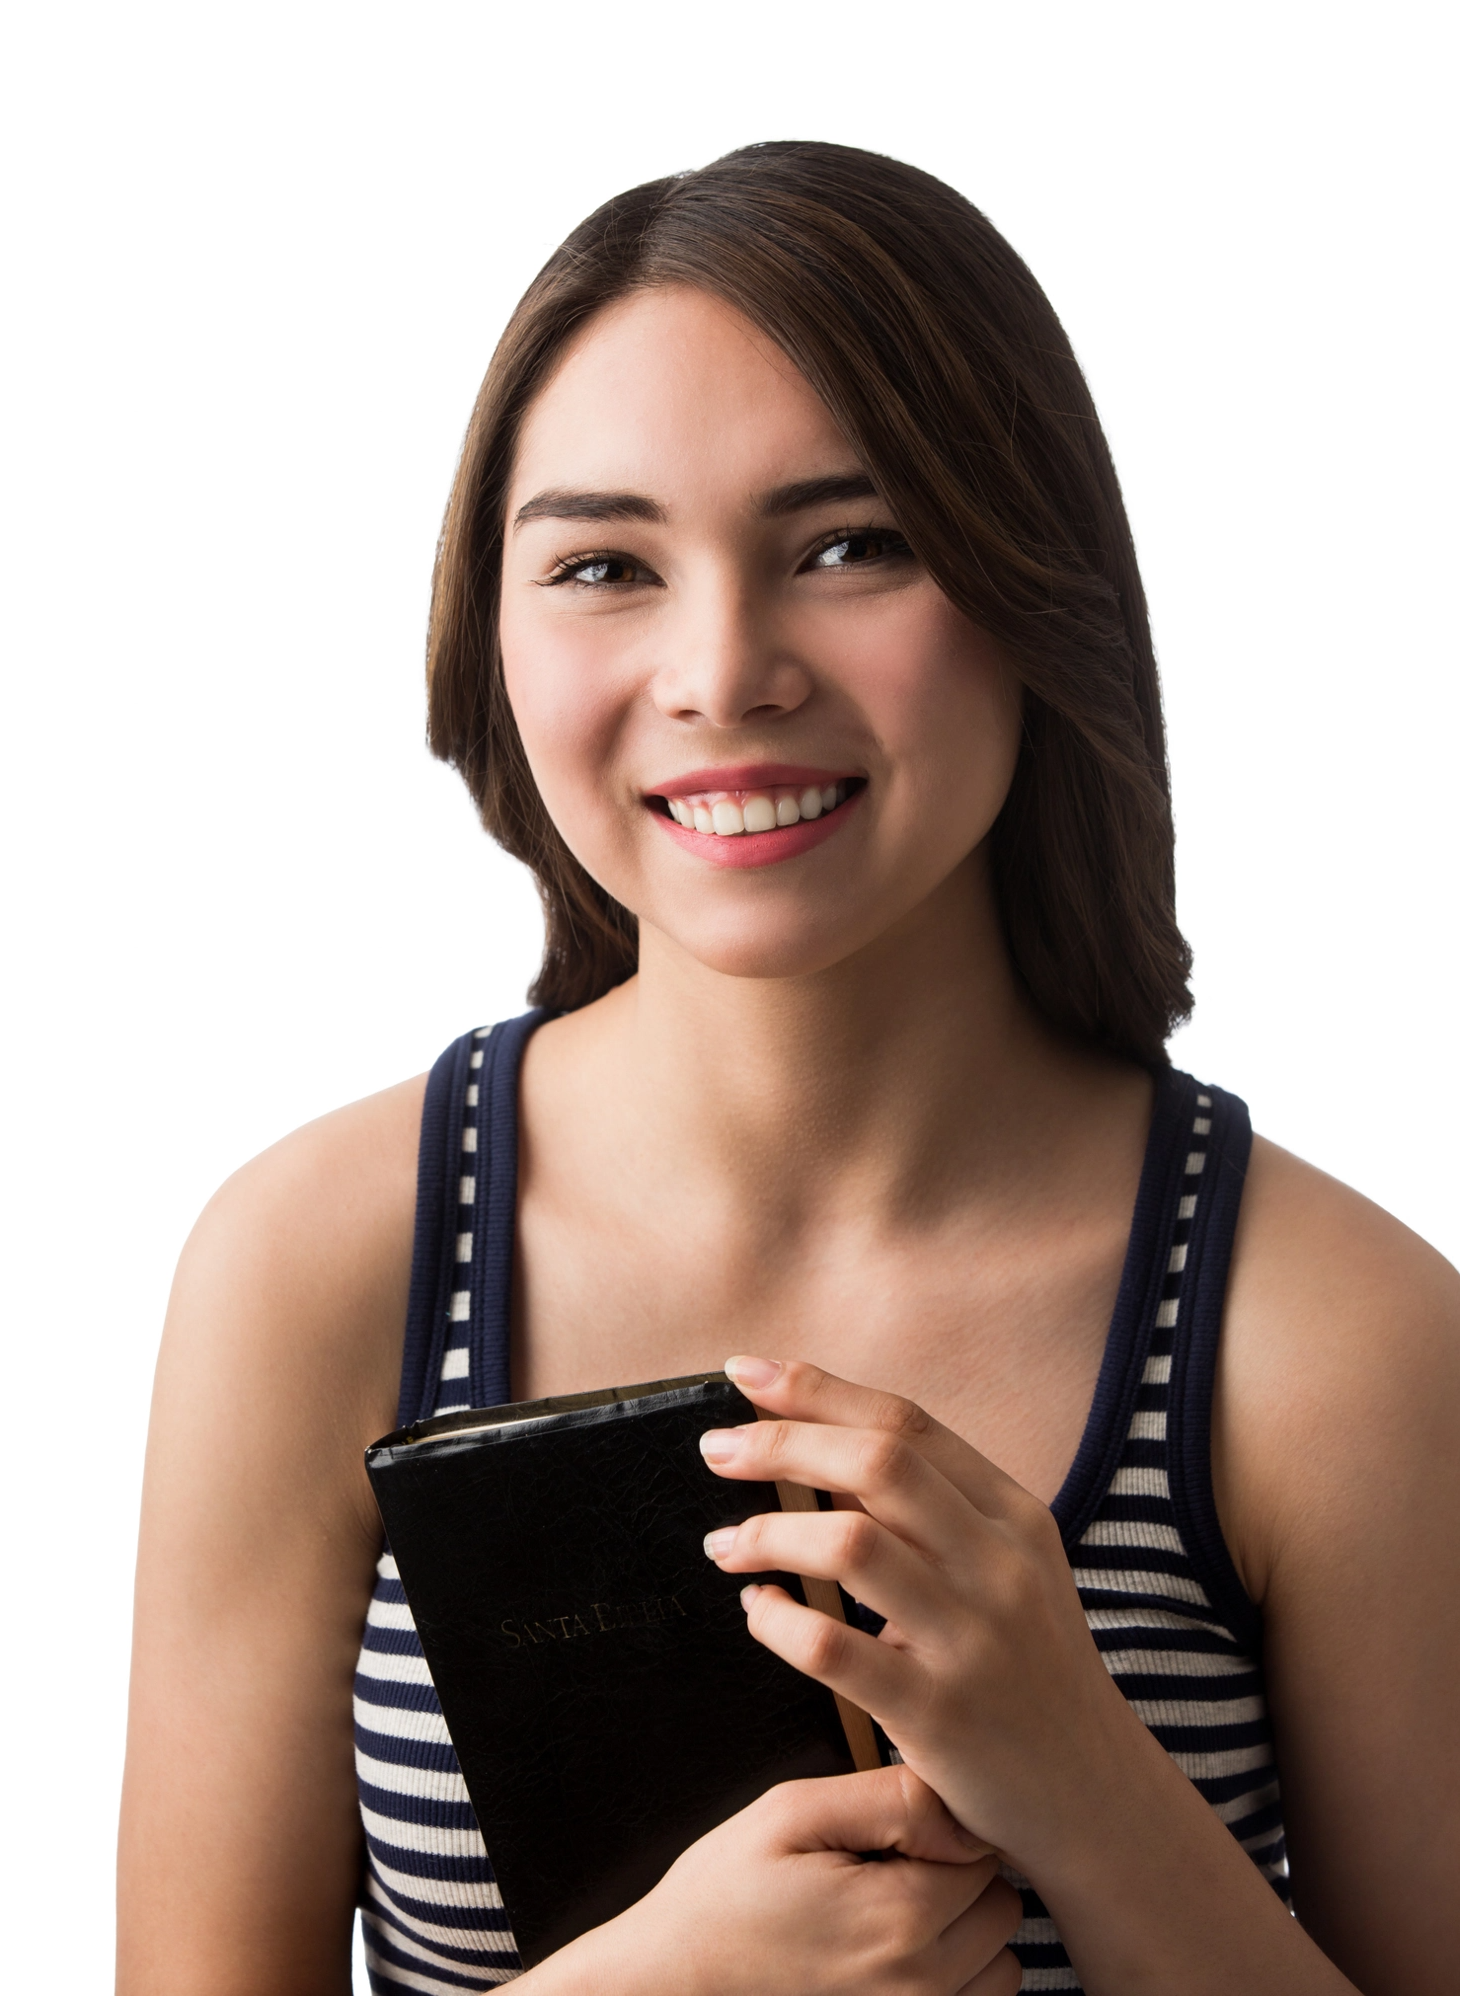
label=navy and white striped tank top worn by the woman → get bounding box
[356,1012,1288,1996]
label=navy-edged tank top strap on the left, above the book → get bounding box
[399,1010,551,1425]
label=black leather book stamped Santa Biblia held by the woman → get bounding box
[365,1373,877,1966]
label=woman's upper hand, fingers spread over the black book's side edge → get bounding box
[701,1357,1148,1872]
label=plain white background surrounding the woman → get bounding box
[0,0,1460,1992]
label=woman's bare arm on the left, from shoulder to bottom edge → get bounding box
[118,1080,423,1996]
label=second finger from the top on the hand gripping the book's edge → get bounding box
[699,1421,995,1561]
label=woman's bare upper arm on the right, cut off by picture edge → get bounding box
[1214,1144,1460,1996]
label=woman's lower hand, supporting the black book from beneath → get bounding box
[521,1766,1021,1996]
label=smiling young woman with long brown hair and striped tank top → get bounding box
[122,144,1460,1996]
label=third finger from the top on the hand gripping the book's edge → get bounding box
[705,1511,947,1639]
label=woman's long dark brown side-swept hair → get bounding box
[427,142,1190,1064]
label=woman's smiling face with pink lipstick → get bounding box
[501,287,1019,978]
